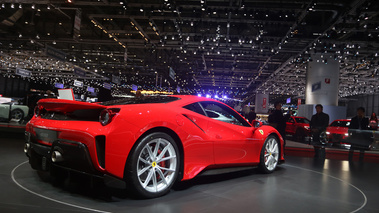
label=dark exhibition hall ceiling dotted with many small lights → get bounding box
[0,0,379,100]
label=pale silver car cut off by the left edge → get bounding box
[0,102,29,122]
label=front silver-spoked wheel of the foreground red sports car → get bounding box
[258,135,280,174]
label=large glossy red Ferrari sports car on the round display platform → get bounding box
[24,95,284,198]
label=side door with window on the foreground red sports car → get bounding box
[200,101,260,164]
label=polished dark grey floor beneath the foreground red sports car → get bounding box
[0,132,379,213]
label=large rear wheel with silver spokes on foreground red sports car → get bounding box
[125,132,180,198]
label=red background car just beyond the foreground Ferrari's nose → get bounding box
[286,116,311,141]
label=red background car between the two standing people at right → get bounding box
[326,119,350,146]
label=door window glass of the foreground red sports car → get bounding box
[200,101,250,127]
